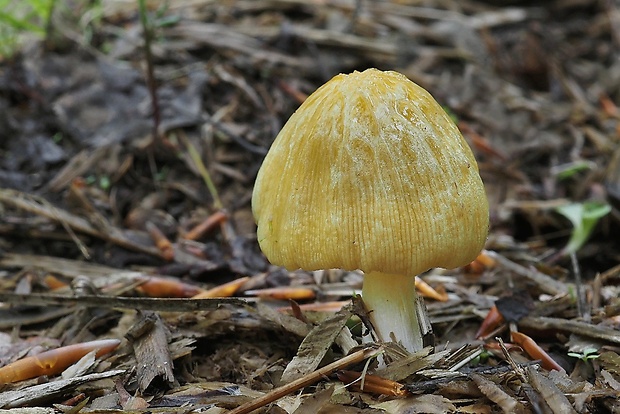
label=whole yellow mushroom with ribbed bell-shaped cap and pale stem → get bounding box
[252,69,489,352]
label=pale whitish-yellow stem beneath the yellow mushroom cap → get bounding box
[362,272,423,352]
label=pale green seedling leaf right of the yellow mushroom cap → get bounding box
[556,201,611,254]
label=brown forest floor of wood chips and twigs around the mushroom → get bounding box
[0,0,620,414]
